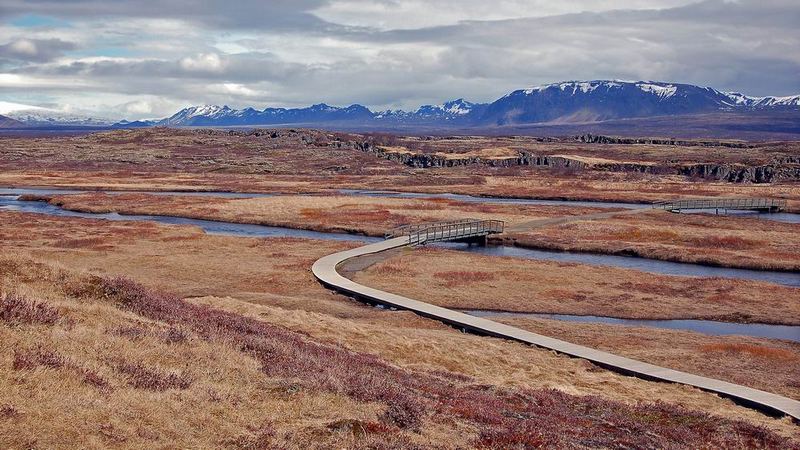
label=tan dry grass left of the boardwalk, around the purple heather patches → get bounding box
[0,213,795,447]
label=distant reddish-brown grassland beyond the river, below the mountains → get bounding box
[0,129,800,211]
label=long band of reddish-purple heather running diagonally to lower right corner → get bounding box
[97,278,796,449]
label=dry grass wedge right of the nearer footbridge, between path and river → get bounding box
[508,211,800,271]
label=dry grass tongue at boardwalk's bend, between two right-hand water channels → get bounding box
[354,244,800,324]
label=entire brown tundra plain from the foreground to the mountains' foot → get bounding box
[0,129,800,448]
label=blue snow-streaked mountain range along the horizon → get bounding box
[0,80,800,128]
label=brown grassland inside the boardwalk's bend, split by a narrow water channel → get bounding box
[353,248,800,398]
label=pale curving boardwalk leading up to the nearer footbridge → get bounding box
[311,236,800,421]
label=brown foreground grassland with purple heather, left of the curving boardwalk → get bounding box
[0,212,798,448]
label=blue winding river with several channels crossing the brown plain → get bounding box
[0,188,800,342]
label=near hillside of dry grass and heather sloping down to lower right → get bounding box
[0,256,794,448]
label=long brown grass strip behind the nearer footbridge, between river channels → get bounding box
[12,187,800,271]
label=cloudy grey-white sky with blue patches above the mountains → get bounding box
[0,0,800,119]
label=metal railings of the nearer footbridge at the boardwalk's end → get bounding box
[386,219,505,245]
